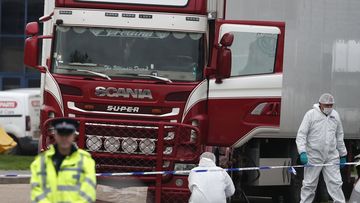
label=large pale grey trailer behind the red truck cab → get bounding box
[224,0,360,202]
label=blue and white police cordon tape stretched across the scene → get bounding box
[0,162,360,178]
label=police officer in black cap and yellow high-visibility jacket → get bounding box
[30,118,96,203]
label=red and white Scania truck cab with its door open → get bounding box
[25,0,284,202]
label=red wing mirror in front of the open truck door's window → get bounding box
[215,33,234,83]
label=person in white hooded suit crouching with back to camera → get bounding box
[188,152,235,203]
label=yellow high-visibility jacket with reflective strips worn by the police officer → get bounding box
[30,146,96,203]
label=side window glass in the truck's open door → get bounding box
[230,32,278,76]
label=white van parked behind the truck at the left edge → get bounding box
[0,88,41,153]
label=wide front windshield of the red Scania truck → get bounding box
[52,26,205,81]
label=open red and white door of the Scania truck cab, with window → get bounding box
[207,20,285,147]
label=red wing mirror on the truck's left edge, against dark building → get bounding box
[24,22,46,73]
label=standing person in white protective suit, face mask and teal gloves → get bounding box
[296,93,347,203]
